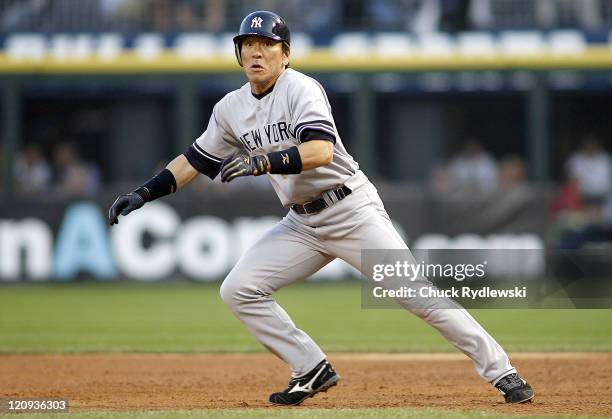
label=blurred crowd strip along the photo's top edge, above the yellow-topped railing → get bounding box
[0,0,612,37]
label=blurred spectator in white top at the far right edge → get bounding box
[566,136,612,205]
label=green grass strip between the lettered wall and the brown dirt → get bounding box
[0,282,612,353]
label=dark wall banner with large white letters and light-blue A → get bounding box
[0,184,551,282]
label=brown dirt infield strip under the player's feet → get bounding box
[0,353,612,415]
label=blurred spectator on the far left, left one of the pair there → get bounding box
[14,144,51,193]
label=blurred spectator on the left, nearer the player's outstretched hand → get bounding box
[54,143,100,195]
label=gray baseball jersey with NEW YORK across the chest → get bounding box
[187,68,365,206]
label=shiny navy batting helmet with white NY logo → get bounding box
[234,10,291,65]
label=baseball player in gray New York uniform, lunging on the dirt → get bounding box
[109,11,533,405]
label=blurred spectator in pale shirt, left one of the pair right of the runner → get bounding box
[448,140,498,192]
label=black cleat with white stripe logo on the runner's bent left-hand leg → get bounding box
[270,360,340,406]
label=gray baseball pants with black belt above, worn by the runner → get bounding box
[221,182,516,384]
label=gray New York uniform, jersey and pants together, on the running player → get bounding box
[185,69,516,383]
